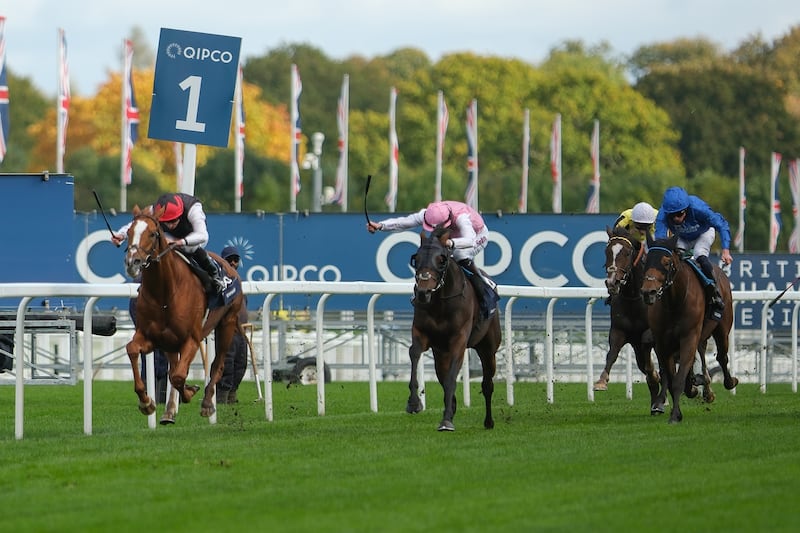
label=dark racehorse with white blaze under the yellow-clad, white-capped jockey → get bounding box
[594,226,666,415]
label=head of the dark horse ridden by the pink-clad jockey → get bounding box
[410,226,452,304]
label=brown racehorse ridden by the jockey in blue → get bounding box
[642,236,739,423]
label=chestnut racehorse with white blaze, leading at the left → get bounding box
[125,206,244,424]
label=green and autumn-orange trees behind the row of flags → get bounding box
[0,26,800,251]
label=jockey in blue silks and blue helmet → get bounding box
[656,187,733,320]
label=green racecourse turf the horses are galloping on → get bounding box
[0,382,800,533]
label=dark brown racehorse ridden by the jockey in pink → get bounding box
[406,226,502,431]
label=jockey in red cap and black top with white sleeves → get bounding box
[111,193,225,292]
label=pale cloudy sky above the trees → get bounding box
[0,0,800,95]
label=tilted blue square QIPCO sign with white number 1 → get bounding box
[147,28,242,147]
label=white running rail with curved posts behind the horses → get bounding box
[0,281,800,439]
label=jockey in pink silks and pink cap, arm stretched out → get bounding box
[367,201,498,318]
